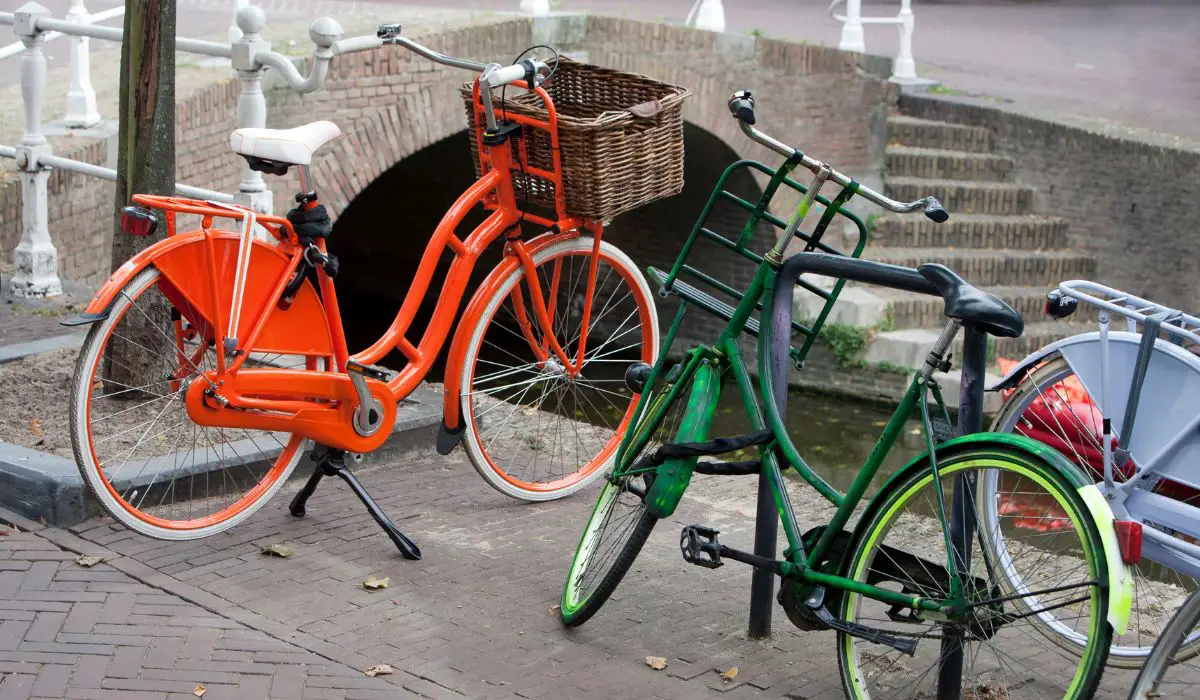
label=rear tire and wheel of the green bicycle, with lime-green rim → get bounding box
[838,447,1112,700]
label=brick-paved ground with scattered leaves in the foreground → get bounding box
[0,437,1133,700]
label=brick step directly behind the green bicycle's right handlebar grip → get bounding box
[871,214,1067,250]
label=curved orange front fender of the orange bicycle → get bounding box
[438,229,580,454]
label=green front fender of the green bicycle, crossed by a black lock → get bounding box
[646,363,721,517]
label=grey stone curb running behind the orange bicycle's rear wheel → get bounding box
[0,386,442,527]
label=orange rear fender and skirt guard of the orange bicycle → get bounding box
[75,231,334,357]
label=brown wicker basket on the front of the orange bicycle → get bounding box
[462,59,690,221]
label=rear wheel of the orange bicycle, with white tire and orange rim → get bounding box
[72,269,305,533]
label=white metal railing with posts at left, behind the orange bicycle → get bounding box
[0,0,378,297]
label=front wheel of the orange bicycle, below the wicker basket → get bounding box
[463,247,658,492]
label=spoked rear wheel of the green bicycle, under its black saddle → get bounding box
[838,449,1112,700]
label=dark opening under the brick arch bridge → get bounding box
[329,122,772,381]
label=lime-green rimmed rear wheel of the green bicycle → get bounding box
[839,456,1106,700]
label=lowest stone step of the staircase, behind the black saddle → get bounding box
[860,321,1096,370]
